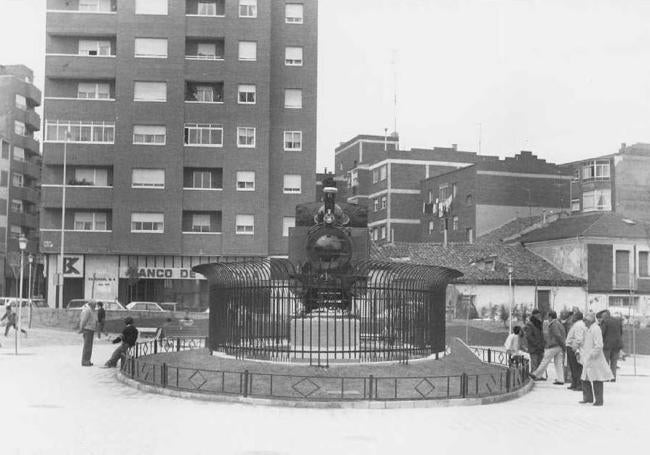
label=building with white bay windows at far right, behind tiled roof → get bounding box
[563,143,650,221]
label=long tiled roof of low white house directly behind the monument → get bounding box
[371,242,585,286]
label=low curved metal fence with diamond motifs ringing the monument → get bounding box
[122,338,529,401]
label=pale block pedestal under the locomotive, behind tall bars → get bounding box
[289,313,361,359]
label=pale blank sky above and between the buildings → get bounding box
[0,0,650,171]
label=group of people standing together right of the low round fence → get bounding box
[505,308,623,406]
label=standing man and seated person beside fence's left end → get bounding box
[79,301,138,368]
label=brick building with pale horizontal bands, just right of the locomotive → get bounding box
[335,134,498,242]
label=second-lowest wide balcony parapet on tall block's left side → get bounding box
[41,185,113,210]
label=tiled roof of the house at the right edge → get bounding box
[516,212,650,243]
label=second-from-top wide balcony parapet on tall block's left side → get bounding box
[45,54,116,79]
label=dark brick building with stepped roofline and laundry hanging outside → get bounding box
[420,151,571,243]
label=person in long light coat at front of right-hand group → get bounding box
[579,313,614,406]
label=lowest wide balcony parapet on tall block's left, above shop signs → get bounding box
[40,229,113,254]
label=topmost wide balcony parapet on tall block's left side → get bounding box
[47,10,117,36]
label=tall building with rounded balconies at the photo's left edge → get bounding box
[0,65,41,295]
